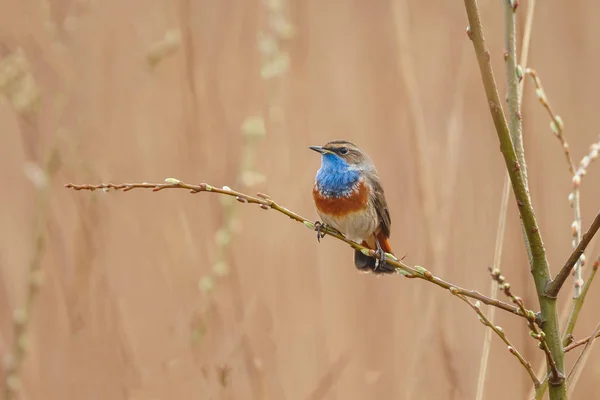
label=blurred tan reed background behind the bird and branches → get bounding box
[0,0,600,400]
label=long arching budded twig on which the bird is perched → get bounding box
[65,178,531,318]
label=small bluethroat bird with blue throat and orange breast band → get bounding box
[310,140,395,273]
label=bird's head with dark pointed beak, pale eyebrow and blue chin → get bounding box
[309,140,375,172]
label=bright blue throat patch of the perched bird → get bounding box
[317,153,360,197]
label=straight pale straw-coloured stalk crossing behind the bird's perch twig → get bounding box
[475,174,510,400]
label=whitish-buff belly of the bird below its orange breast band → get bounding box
[319,207,378,243]
